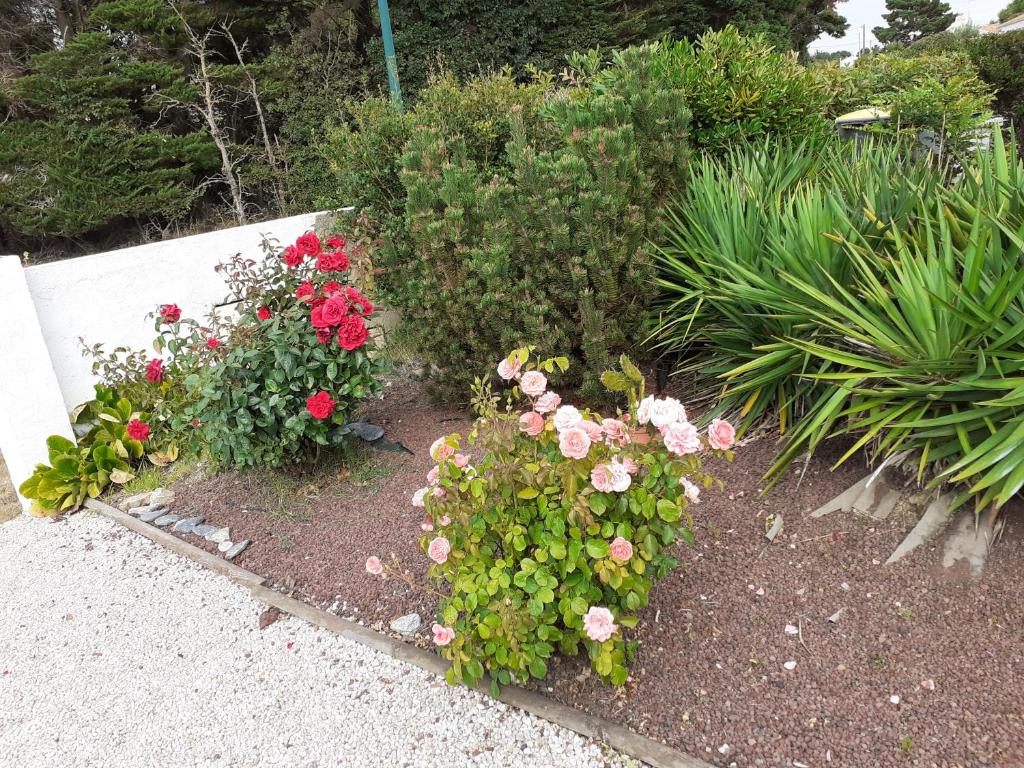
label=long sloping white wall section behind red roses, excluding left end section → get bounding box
[25,213,319,411]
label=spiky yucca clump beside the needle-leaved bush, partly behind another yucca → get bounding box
[651,141,934,433]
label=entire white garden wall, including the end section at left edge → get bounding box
[0,213,329,512]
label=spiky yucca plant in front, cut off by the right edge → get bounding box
[769,132,1024,518]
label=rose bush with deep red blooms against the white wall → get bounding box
[85,232,378,466]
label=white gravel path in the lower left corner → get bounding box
[0,514,636,768]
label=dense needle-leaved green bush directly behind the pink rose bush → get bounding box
[332,46,689,395]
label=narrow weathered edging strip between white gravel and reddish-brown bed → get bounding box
[85,499,713,768]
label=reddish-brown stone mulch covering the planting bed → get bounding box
[167,380,1024,768]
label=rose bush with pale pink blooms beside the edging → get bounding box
[367,347,734,688]
